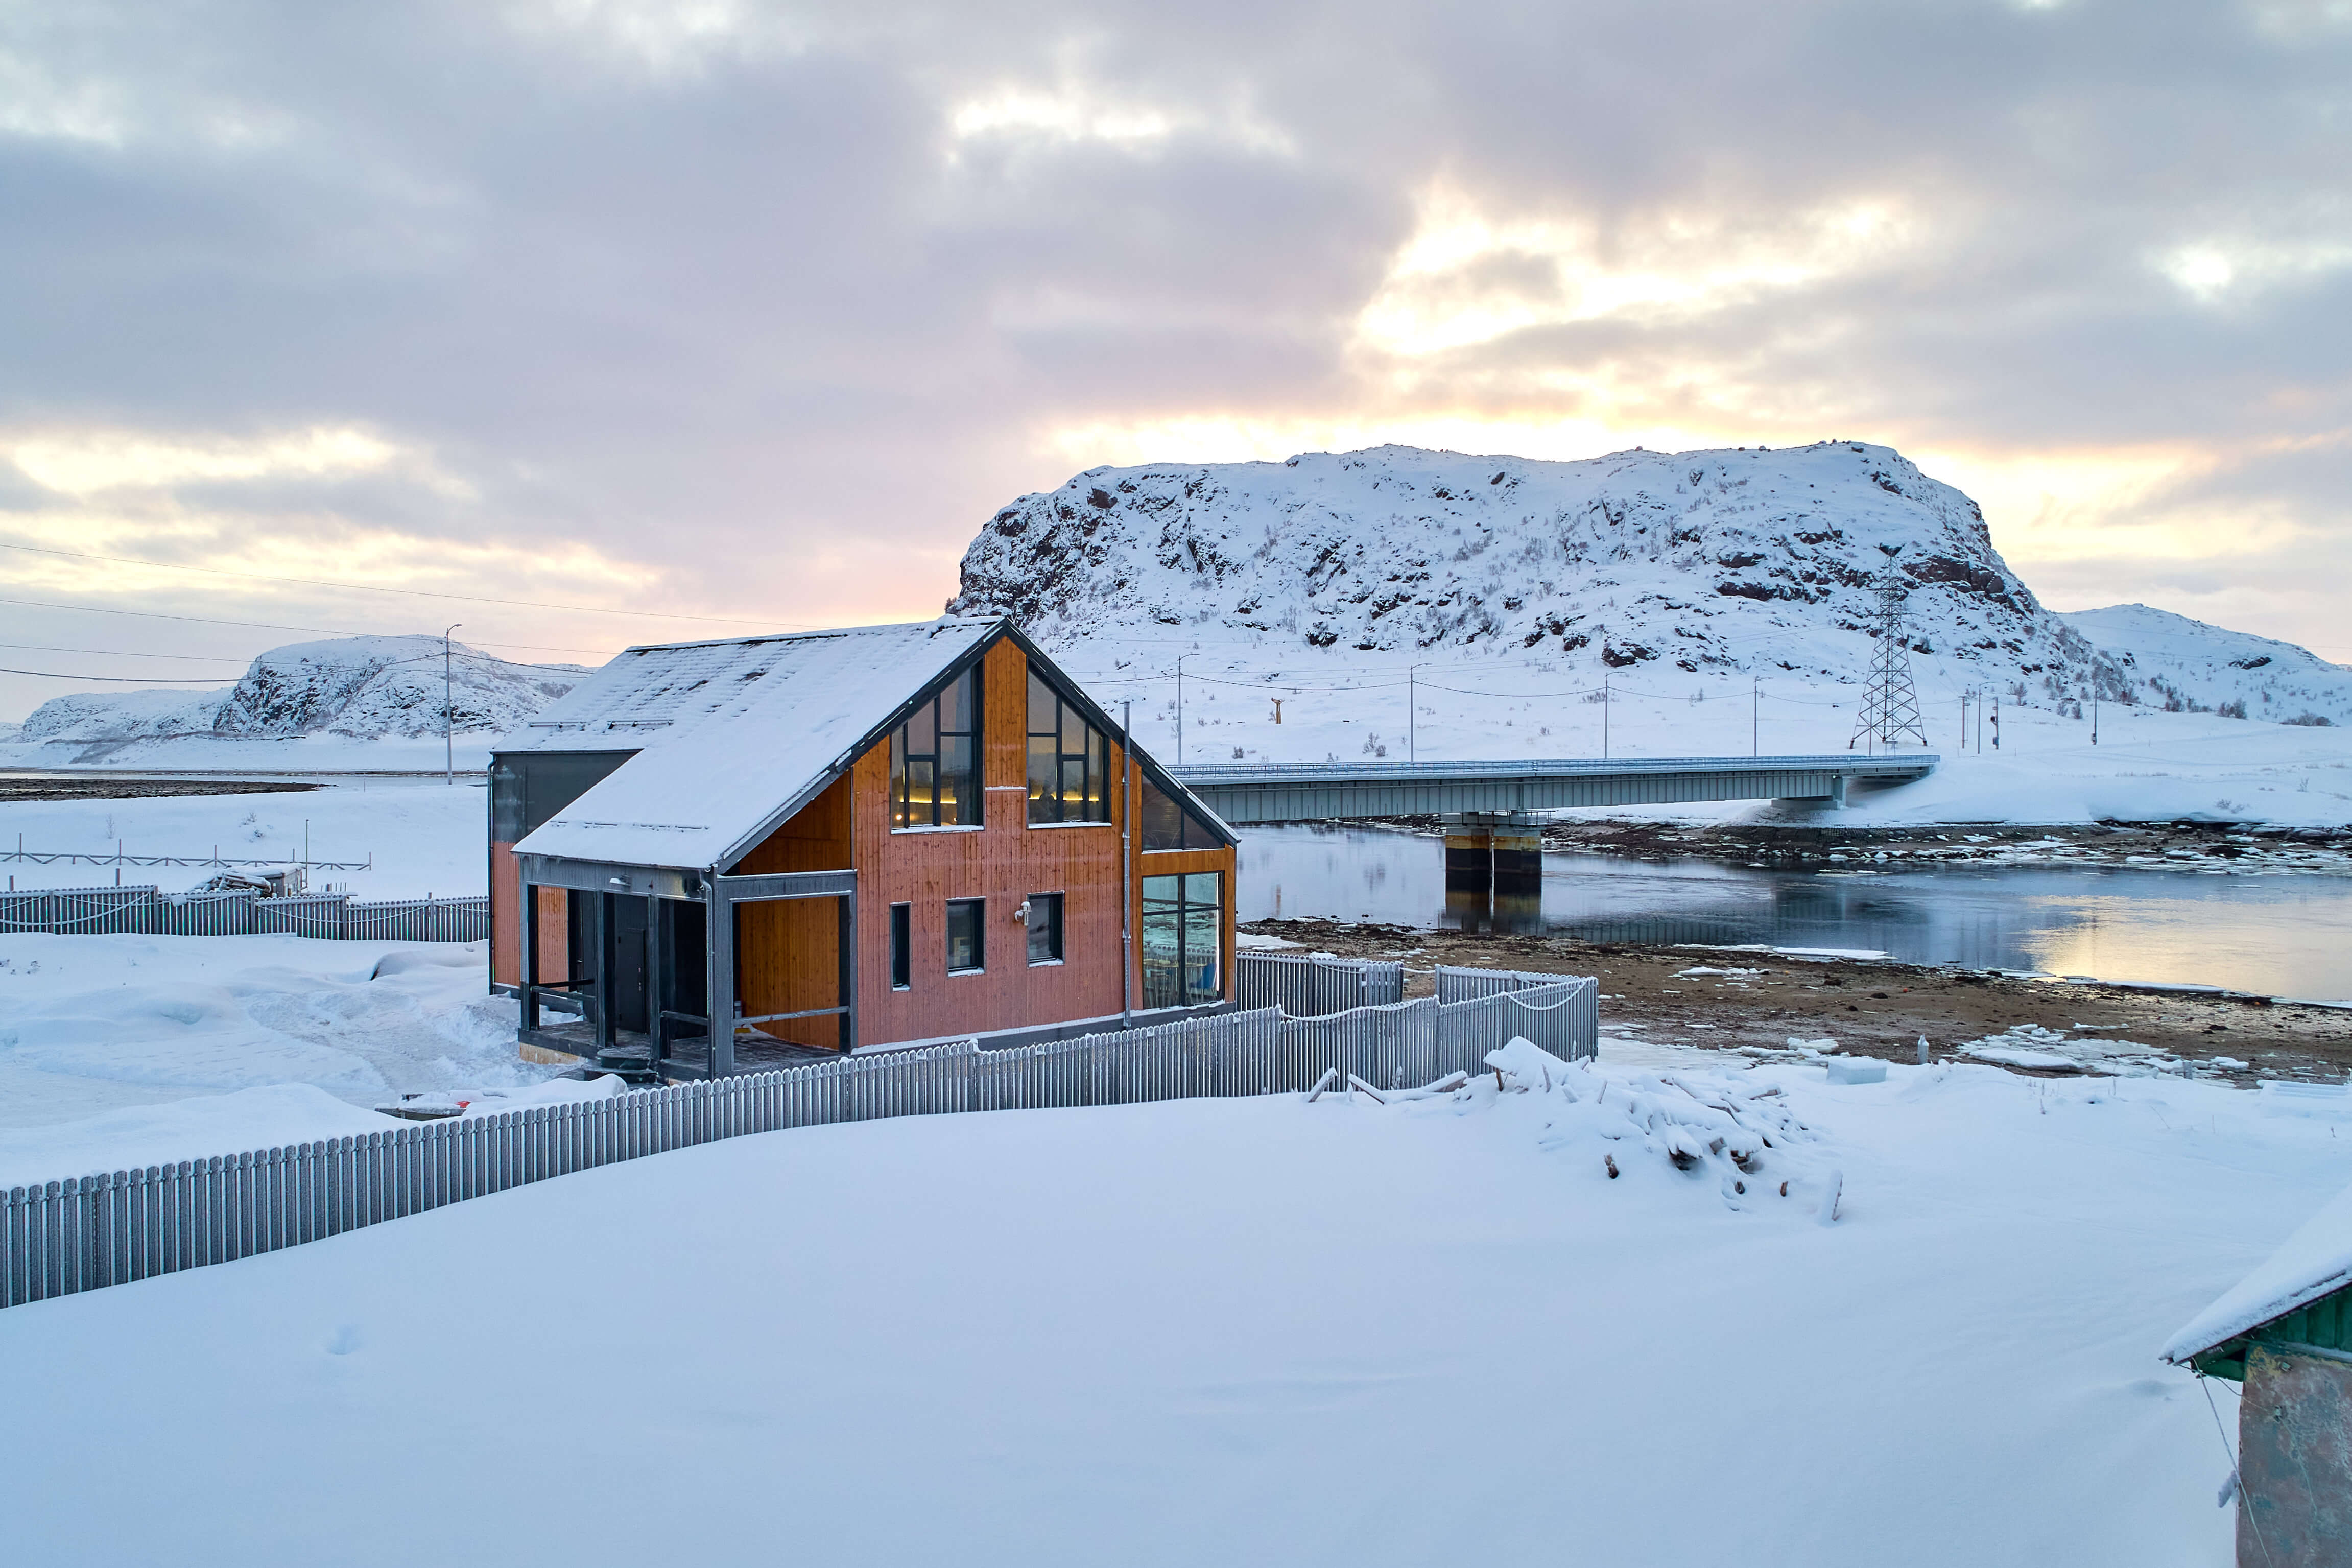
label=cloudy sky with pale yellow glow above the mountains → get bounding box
[0,0,2352,717]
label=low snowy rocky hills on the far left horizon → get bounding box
[19,637,586,748]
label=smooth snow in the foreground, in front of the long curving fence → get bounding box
[0,1046,2323,1568]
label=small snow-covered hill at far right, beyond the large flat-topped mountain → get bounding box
[2065,604,2352,724]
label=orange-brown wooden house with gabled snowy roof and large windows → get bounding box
[489,619,1235,1077]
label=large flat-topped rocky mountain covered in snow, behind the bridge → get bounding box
[950,442,2326,717]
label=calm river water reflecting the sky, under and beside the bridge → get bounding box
[1240,827,2352,999]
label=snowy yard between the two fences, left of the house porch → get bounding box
[0,933,551,1142]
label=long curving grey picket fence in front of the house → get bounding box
[0,968,1599,1307]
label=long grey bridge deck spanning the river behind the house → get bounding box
[1169,752,1938,827]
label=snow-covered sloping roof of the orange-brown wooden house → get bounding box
[498,616,1004,867]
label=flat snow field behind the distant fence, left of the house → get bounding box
[0,778,489,898]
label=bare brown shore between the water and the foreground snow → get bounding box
[1244,919,2352,1079]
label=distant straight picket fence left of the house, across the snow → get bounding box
[0,886,489,943]
